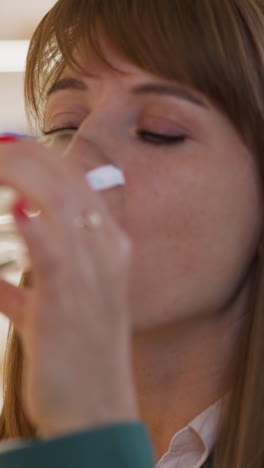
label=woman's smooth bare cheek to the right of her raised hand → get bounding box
[126,155,262,328]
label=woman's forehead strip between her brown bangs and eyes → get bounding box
[47,31,209,108]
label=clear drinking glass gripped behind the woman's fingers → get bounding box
[0,130,77,279]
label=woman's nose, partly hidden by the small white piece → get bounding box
[64,131,125,228]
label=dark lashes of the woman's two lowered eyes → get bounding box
[43,127,186,146]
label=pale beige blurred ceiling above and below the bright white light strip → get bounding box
[0,0,56,133]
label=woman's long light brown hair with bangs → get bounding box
[0,0,264,468]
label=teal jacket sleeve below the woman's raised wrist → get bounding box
[0,423,155,468]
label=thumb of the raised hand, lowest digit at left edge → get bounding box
[0,279,32,330]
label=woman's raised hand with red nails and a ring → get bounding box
[0,141,138,437]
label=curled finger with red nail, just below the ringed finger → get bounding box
[12,201,95,306]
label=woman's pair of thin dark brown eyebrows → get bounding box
[46,78,208,109]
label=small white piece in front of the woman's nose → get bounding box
[85,165,126,190]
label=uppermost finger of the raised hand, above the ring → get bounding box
[0,141,115,234]
